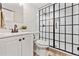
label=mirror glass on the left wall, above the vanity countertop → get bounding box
[2,9,14,29]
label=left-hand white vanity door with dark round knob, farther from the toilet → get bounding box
[6,37,21,56]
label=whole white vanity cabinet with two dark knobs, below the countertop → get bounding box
[0,34,33,56]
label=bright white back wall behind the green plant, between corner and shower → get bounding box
[23,3,45,31]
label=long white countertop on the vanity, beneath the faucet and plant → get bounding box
[0,32,39,39]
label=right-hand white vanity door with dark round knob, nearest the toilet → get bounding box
[22,34,33,56]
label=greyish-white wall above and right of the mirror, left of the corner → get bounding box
[2,3,23,23]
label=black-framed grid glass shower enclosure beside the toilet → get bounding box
[39,3,79,55]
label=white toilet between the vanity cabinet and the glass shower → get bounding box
[35,40,49,56]
